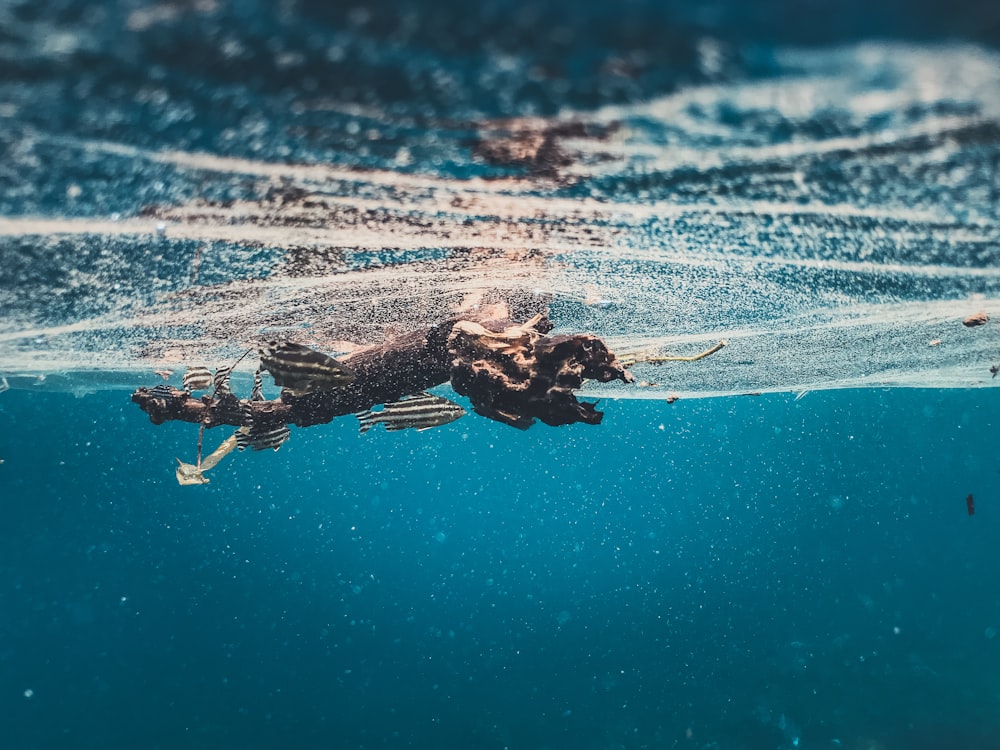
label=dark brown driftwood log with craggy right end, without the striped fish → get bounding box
[132,315,632,429]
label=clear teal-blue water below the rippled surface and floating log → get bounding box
[0,390,1000,750]
